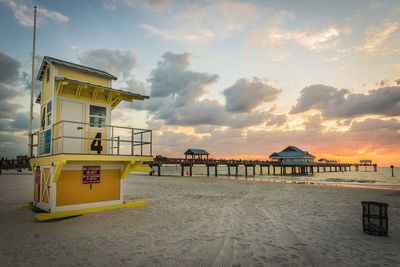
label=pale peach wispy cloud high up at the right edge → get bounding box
[356,21,399,53]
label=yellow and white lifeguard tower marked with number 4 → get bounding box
[30,56,153,216]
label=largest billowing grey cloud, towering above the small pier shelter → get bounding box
[134,52,285,128]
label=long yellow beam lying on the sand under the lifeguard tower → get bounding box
[36,201,147,221]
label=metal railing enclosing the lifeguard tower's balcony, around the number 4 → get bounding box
[32,121,152,157]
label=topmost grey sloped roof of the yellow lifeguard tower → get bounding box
[37,56,117,81]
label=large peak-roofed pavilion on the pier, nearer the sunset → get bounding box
[269,146,315,165]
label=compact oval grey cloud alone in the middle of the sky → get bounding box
[223,77,281,112]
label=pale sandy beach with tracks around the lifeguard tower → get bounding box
[0,174,400,266]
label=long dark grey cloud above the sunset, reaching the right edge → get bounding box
[290,84,400,119]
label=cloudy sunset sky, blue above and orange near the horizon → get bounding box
[0,0,400,166]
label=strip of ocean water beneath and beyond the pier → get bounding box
[153,166,400,185]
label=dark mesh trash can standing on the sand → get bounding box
[361,201,389,236]
